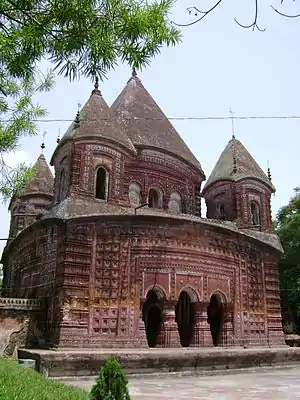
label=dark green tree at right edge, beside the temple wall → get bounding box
[276,188,300,330]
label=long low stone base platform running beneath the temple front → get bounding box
[18,346,300,378]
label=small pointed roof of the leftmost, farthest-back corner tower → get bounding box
[21,154,54,196]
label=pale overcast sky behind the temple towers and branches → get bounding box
[0,0,300,252]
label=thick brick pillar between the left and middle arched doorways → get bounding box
[157,302,181,347]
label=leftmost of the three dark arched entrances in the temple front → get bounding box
[143,288,164,347]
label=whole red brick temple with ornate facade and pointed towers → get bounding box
[2,73,284,348]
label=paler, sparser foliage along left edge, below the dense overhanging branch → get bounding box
[0,73,53,201]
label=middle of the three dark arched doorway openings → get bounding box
[175,291,195,347]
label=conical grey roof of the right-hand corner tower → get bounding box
[203,137,275,192]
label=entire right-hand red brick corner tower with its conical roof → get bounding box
[202,135,275,231]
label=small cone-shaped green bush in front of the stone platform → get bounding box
[90,358,130,400]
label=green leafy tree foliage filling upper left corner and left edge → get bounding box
[0,0,181,202]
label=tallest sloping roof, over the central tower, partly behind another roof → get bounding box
[111,73,203,173]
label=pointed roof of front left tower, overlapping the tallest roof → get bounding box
[59,82,135,151]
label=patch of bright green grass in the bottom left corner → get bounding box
[0,357,89,400]
